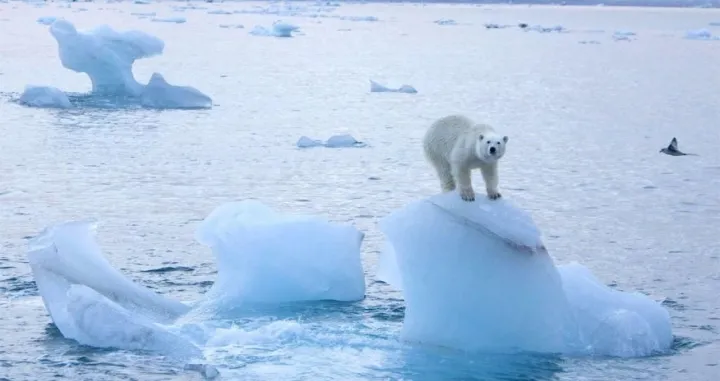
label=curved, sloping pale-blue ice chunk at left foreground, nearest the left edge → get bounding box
[28,221,189,348]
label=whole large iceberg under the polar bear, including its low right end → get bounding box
[378,192,672,357]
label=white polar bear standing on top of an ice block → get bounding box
[423,115,508,201]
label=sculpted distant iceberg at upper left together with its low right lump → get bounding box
[16,20,212,108]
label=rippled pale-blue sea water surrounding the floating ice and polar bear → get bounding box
[0,2,720,381]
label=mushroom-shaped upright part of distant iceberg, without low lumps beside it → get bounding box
[50,20,165,96]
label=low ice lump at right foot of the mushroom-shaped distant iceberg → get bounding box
[140,73,212,109]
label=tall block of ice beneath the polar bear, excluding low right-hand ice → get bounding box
[380,192,572,352]
